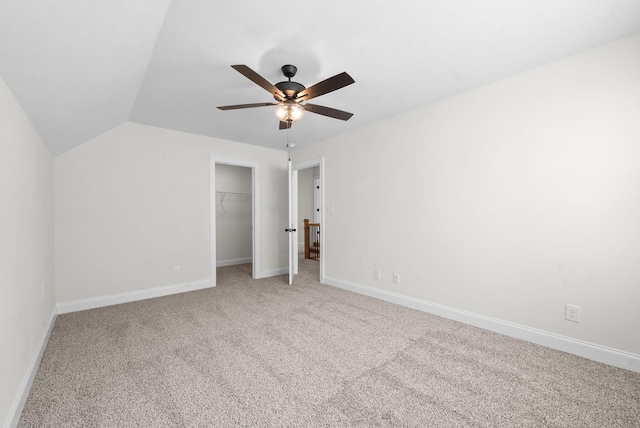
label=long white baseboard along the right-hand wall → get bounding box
[325,276,640,373]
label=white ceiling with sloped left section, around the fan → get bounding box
[0,0,640,154]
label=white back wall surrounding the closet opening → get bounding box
[55,123,287,302]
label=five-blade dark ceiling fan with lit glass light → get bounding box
[218,64,355,129]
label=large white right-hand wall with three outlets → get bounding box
[293,34,640,355]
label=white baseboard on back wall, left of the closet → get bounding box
[57,279,211,314]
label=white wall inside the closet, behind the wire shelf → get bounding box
[216,164,253,265]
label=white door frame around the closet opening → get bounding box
[209,155,260,287]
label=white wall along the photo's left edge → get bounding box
[0,78,55,426]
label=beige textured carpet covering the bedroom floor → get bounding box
[19,260,640,427]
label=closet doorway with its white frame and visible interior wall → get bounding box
[209,159,257,286]
